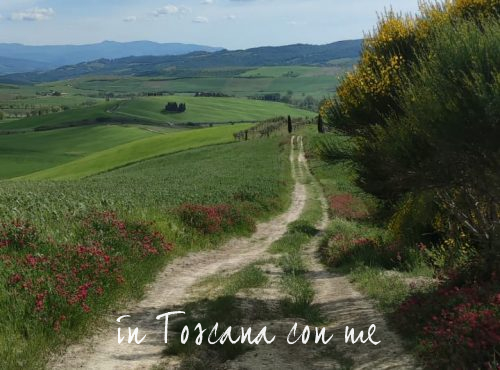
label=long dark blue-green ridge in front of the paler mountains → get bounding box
[0,40,363,83]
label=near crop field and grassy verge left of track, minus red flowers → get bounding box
[0,137,291,369]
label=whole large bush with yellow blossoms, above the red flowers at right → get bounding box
[322,0,500,275]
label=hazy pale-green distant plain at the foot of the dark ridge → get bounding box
[67,66,355,98]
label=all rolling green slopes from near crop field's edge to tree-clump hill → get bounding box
[0,89,314,183]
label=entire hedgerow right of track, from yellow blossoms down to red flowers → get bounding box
[320,0,500,369]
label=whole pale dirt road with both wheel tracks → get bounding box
[48,137,416,370]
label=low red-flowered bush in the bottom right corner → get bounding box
[392,276,500,370]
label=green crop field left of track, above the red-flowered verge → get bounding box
[0,137,290,224]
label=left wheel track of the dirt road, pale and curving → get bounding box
[48,138,306,370]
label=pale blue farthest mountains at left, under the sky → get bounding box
[0,41,222,74]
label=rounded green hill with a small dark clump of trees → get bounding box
[0,96,314,133]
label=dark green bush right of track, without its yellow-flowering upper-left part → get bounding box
[358,21,500,271]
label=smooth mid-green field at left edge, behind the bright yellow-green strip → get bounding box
[0,126,155,179]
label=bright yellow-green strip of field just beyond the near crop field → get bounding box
[24,124,251,180]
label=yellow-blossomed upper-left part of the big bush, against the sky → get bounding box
[320,0,500,132]
